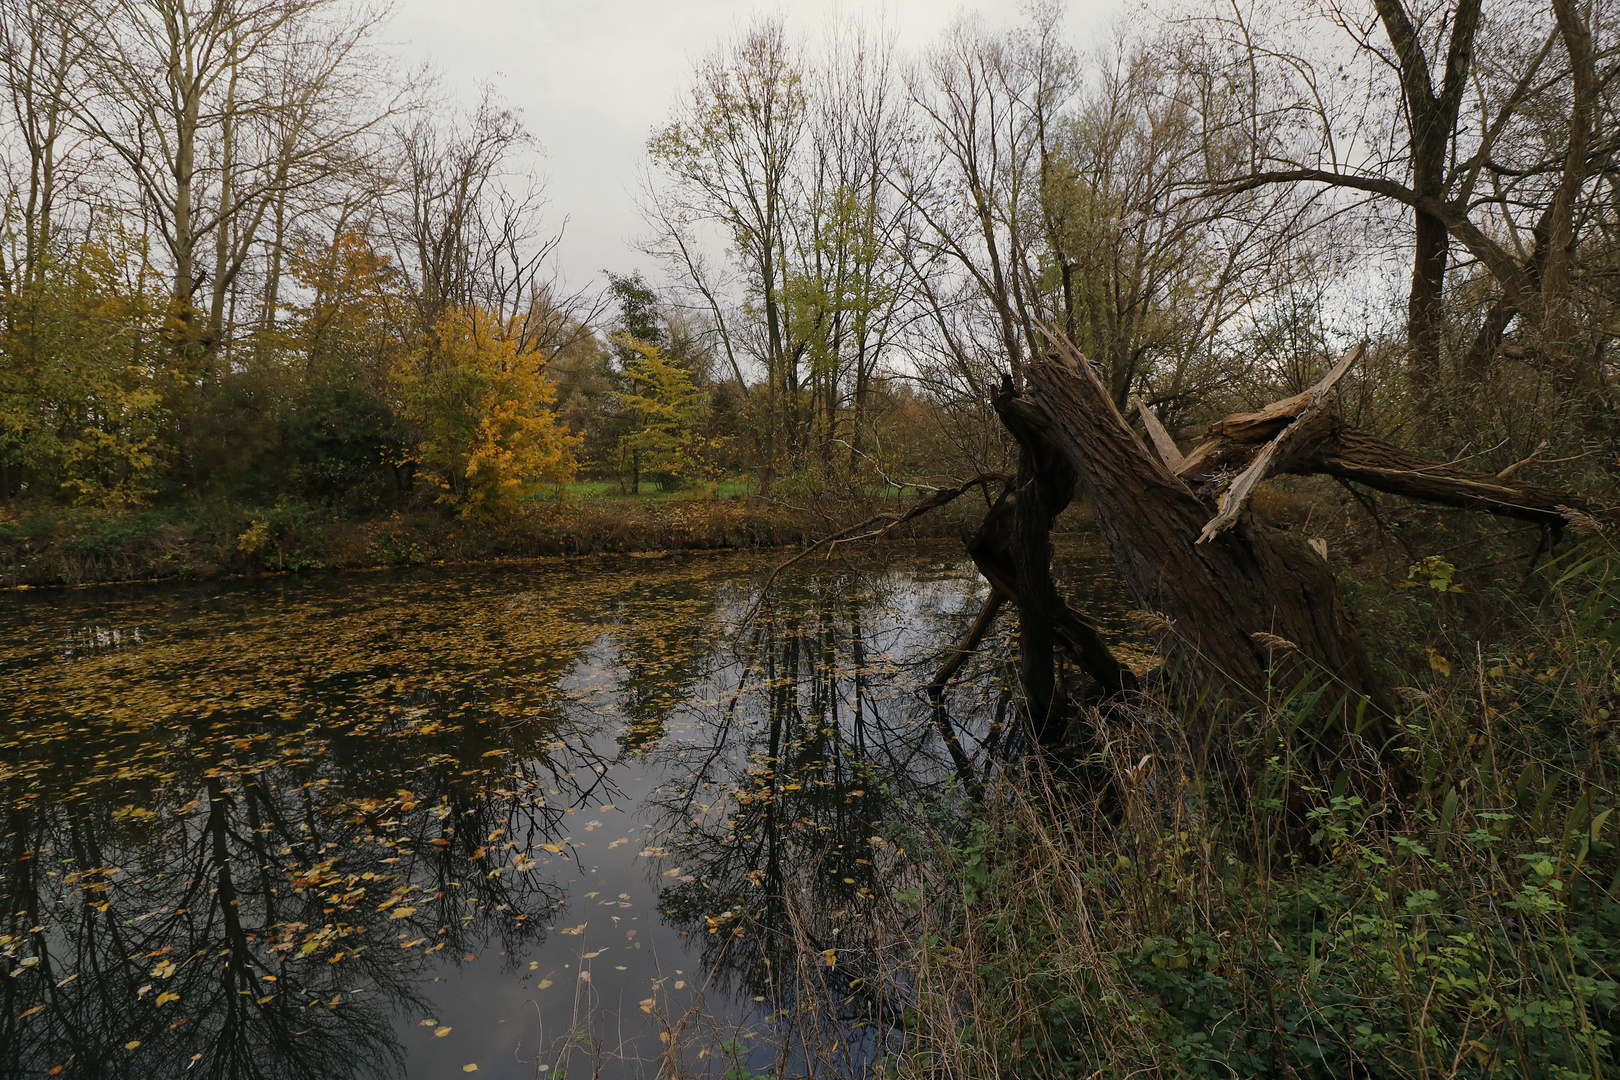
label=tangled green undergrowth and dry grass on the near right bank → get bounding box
[880,546,1620,1080]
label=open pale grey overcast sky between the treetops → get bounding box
[384,0,1121,287]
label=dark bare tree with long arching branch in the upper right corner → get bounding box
[1197,0,1620,406]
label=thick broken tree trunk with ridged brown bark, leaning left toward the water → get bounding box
[998,347,1395,767]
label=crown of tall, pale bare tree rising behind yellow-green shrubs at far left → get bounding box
[60,0,389,366]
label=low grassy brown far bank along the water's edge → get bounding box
[0,495,997,588]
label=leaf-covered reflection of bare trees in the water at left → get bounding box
[0,579,606,1078]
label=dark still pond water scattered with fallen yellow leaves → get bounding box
[0,544,1124,1078]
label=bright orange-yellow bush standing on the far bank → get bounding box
[395,309,582,517]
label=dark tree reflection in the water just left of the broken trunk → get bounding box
[628,567,1001,1072]
